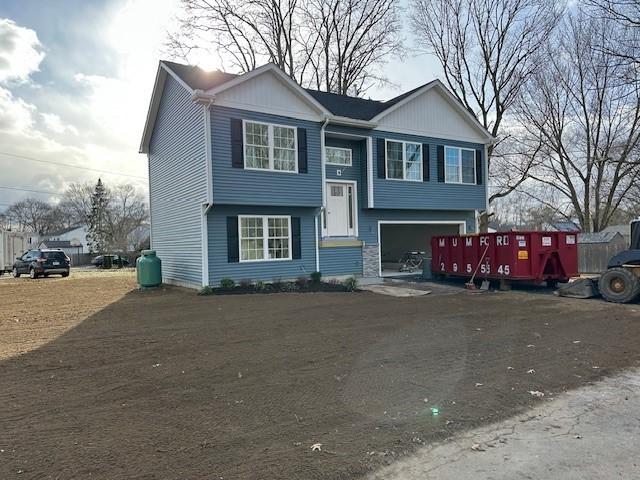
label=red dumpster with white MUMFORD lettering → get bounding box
[431,232,578,283]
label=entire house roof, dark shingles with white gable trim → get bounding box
[140,60,494,153]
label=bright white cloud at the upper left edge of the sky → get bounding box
[0,18,45,83]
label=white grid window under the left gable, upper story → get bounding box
[244,121,298,172]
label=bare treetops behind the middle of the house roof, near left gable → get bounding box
[168,0,402,94]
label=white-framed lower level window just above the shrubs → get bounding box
[238,216,291,262]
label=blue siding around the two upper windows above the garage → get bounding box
[373,131,486,210]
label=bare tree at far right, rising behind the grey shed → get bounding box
[517,13,640,232]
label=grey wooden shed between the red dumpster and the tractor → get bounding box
[578,232,628,273]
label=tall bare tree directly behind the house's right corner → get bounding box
[411,0,562,202]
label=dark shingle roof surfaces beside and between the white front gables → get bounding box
[162,60,438,120]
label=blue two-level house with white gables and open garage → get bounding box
[140,61,493,287]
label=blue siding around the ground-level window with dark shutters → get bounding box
[207,205,318,285]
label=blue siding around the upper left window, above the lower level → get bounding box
[211,105,322,207]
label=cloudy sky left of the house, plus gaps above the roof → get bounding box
[0,0,439,211]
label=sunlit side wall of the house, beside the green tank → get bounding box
[149,75,207,285]
